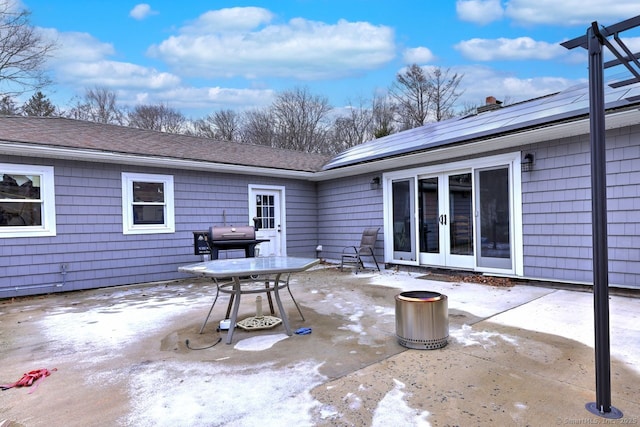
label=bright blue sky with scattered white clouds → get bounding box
[17,0,640,118]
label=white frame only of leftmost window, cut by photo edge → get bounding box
[0,163,56,238]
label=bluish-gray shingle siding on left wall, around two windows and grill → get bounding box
[0,157,317,298]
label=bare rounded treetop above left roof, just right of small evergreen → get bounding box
[67,86,124,125]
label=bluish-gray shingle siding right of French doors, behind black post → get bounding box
[522,126,640,287]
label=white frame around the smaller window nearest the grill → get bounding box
[122,172,176,234]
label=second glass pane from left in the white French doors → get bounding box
[418,178,440,254]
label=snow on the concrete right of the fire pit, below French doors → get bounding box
[370,270,640,372]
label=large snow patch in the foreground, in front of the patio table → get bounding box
[122,361,326,427]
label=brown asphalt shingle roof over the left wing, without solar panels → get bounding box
[0,116,331,172]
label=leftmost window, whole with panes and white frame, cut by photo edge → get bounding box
[0,163,56,238]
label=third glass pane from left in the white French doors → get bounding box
[449,173,473,255]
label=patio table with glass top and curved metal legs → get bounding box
[178,256,320,344]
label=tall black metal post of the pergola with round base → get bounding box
[586,22,622,418]
